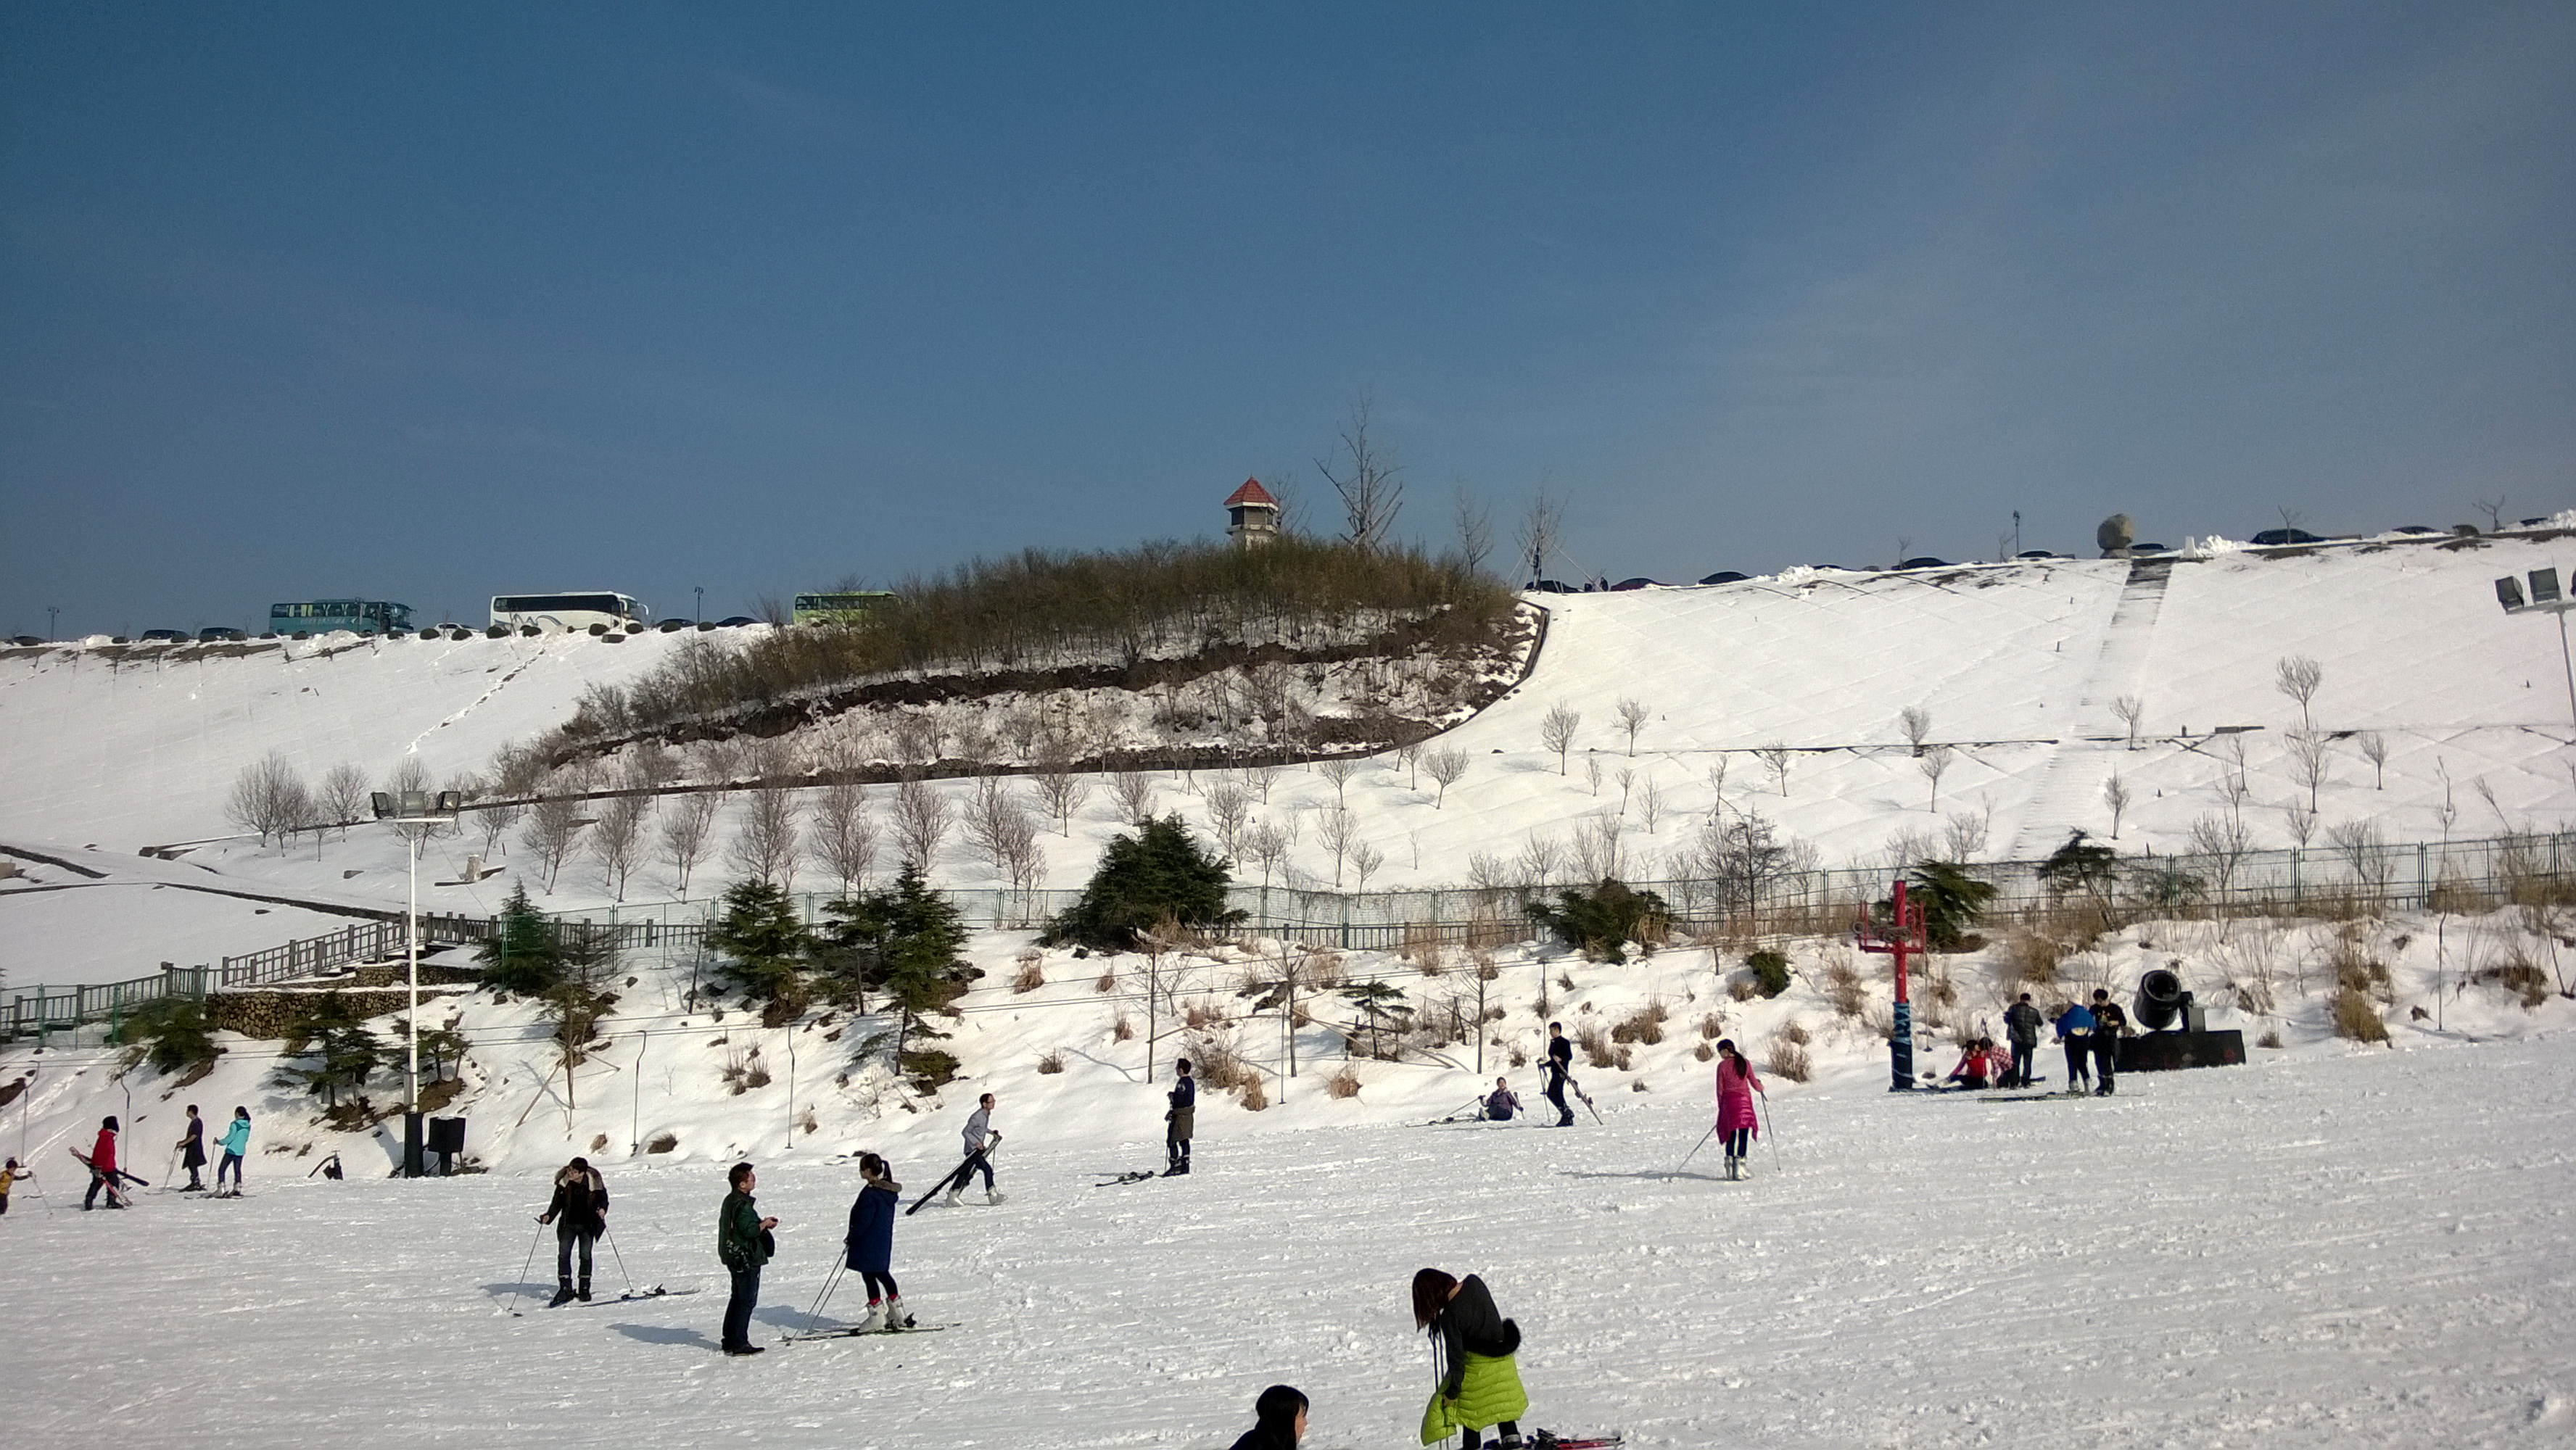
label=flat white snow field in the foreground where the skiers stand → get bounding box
[0,1030,2576,1450]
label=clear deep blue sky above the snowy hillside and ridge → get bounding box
[0,0,2576,634]
